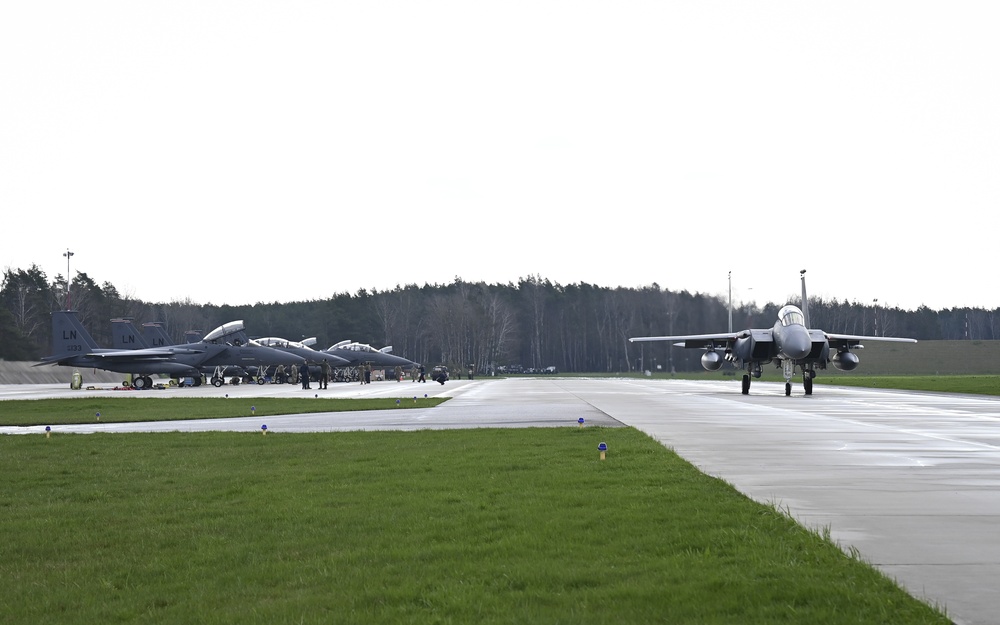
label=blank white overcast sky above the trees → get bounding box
[0,0,1000,309]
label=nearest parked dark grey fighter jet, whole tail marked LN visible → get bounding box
[35,310,303,388]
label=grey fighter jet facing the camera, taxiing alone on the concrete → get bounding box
[629,269,917,396]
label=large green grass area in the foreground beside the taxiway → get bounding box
[0,426,948,625]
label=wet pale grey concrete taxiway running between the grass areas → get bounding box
[0,378,1000,625]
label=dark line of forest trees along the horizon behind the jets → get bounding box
[0,265,1000,372]
